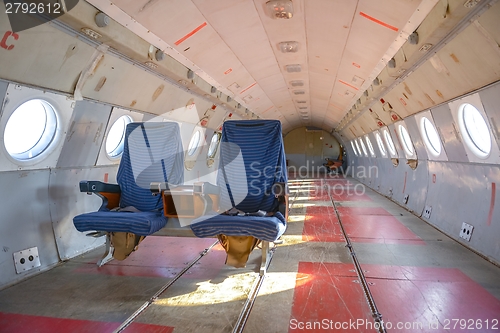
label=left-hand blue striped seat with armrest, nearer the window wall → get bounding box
[73,122,184,236]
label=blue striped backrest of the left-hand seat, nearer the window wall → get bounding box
[116,122,184,211]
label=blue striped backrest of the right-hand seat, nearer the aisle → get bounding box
[217,120,287,213]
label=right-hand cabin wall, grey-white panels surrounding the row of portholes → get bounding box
[341,83,500,263]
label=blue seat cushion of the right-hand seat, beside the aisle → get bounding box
[191,212,286,242]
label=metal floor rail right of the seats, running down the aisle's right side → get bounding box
[325,186,387,333]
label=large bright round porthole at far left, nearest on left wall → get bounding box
[4,99,57,161]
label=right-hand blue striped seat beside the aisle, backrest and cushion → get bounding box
[191,120,288,242]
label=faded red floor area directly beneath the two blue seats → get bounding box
[75,236,226,279]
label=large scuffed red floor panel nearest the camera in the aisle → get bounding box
[288,262,374,332]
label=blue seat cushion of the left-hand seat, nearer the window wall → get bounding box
[73,211,167,236]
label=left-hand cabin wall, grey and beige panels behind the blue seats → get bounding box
[0,2,242,288]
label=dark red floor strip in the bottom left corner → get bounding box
[0,312,174,333]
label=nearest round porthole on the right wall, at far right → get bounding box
[458,103,491,158]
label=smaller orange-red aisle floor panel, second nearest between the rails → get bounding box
[302,206,345,242]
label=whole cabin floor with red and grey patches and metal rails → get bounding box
[0,178,500,333]
